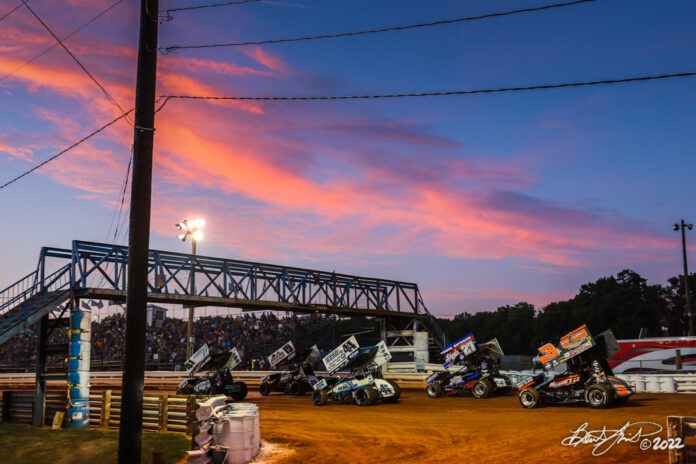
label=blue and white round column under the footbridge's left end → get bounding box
[66,299,92,429]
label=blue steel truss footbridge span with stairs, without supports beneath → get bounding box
[0,241,444,345]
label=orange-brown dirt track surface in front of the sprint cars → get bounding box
[245,390,696,464]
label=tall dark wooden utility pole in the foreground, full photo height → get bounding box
[118,0,159,464]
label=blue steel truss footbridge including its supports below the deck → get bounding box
[0,241,446,427]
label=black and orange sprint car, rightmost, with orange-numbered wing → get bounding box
[518,325,634,409]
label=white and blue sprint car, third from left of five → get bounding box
[312,336,401,406]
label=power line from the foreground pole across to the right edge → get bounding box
[160,72,696,104]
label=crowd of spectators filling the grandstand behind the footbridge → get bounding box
[0,312,333,371]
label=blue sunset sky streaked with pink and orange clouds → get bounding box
[0,0,696,317]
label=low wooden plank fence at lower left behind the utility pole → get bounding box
[2,390,196,435]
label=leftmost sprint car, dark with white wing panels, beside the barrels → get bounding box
[176,345,247,401]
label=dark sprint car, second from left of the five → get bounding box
[259,342,320,396]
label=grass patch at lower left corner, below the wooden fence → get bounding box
[0,423,191,464]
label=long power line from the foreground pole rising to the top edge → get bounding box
[160,0,597,54]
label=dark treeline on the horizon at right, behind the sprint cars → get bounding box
[438,270,696,355]
